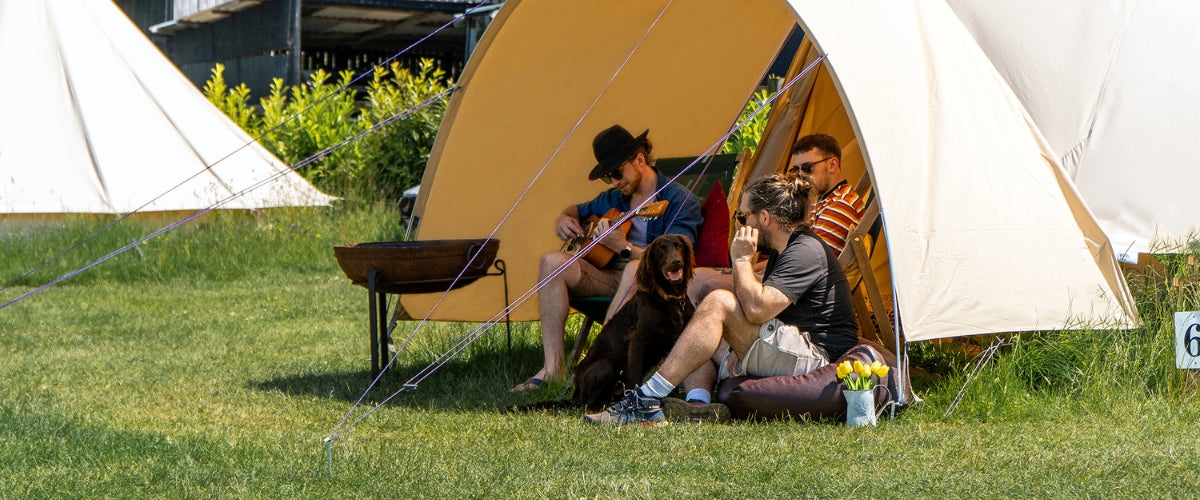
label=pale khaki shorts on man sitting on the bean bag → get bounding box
[716,319,829,381]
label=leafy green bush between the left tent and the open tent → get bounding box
[204,59,454,201]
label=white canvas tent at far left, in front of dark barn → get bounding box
[0,0,331,215]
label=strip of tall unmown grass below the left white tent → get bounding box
[0,203,403,284]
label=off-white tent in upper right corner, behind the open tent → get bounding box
[949,0,1200,261]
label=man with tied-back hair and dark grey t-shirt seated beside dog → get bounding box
[584,174,858,426]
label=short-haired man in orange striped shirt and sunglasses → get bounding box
[787,133,866,255]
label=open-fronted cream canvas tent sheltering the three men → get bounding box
[404,0,1136,341]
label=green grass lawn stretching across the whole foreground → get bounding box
[0,207,1200,499]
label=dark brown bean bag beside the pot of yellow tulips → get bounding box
[716,343,912,418]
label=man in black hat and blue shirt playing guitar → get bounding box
[514,125,703,391]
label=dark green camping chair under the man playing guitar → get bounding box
[566,152,749,371]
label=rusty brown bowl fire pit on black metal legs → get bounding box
[334,239,512,376]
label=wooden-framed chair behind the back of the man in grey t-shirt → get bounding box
[838,173,898,353]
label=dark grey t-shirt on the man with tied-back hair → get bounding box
[763,228,858,361]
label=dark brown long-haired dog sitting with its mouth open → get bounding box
[574,234,696,409]
